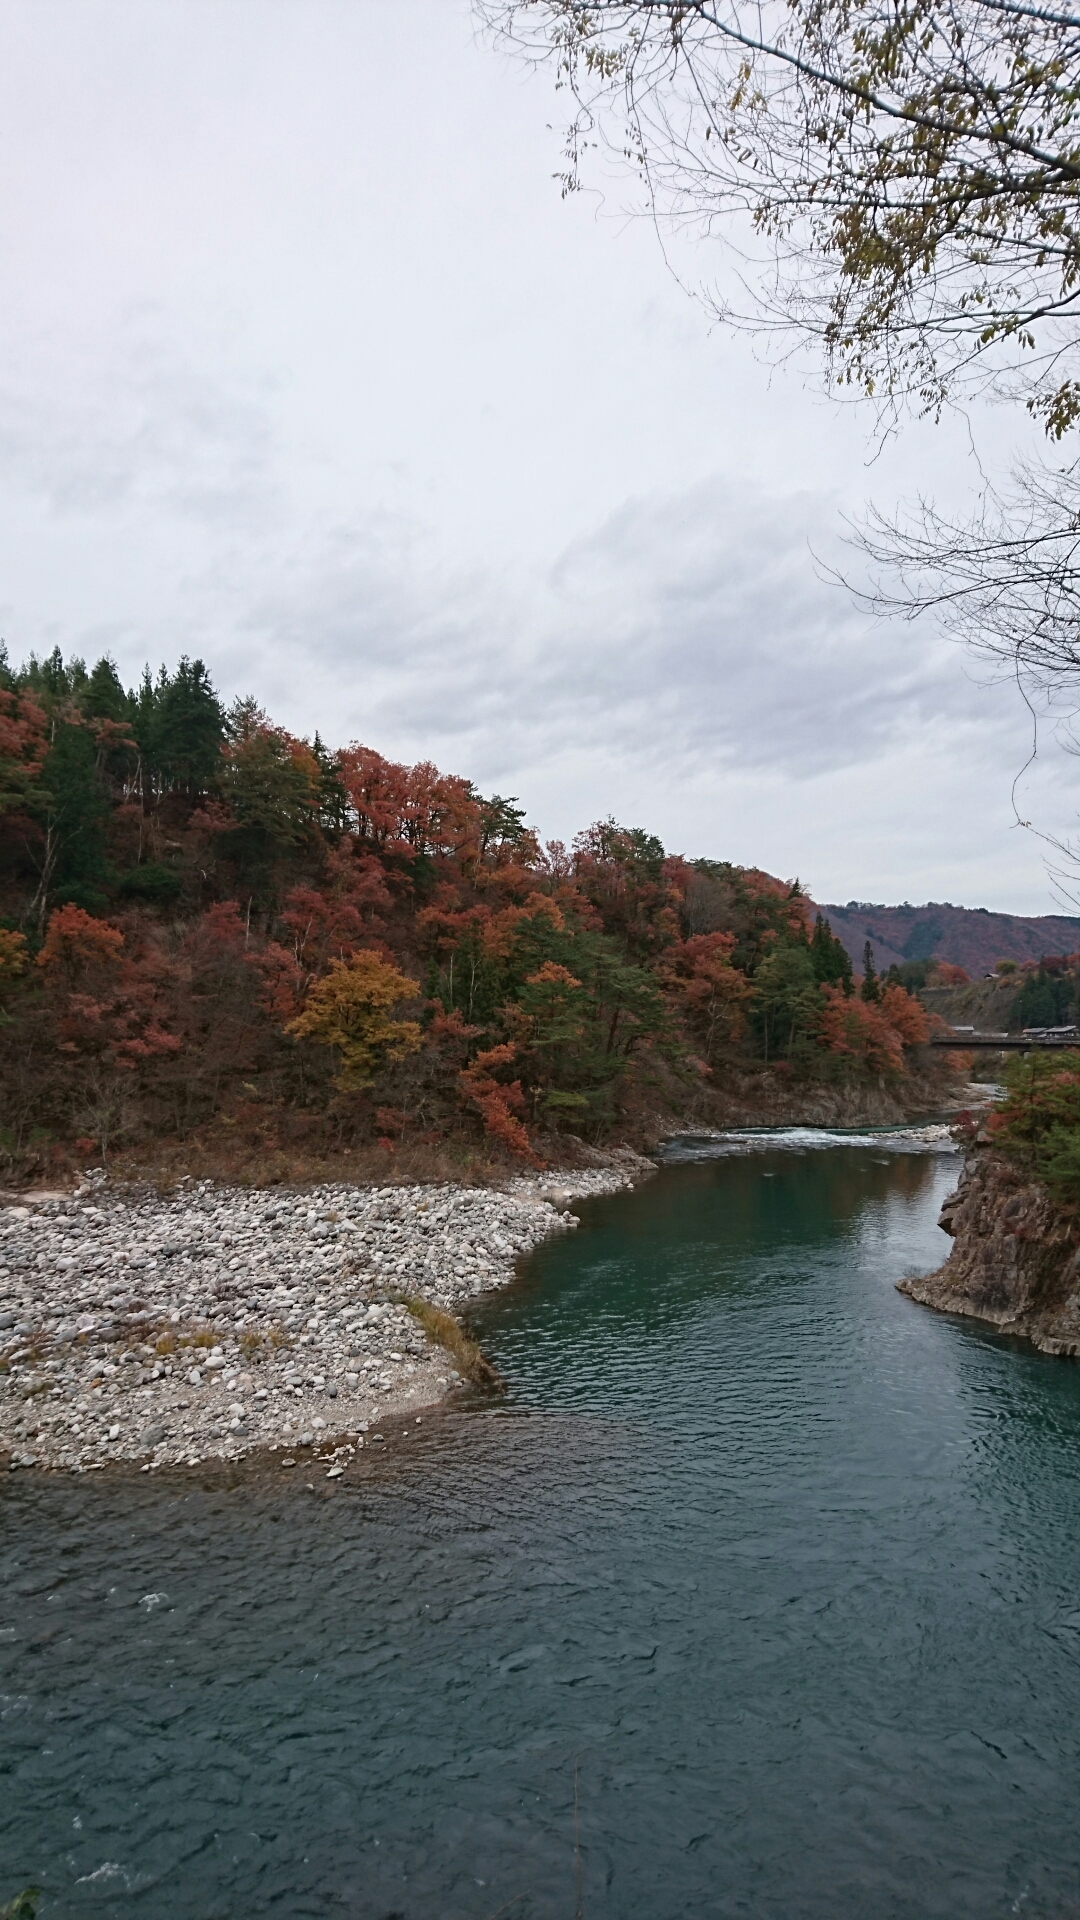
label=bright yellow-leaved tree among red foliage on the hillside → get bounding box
[286,948,421,1087]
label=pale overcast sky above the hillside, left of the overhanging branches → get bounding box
[0,0,1080,912]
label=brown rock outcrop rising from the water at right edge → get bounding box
[899,1152,1080,1356]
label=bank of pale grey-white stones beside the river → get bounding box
[0,1152,653,1475]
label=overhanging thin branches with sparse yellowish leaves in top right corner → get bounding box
[477,0,1080,436]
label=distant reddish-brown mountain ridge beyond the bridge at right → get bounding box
[813,900,1080,979]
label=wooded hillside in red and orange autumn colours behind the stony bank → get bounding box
[0,653,949,1165]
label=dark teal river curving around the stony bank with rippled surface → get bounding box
[0,1140,1080,1920]
